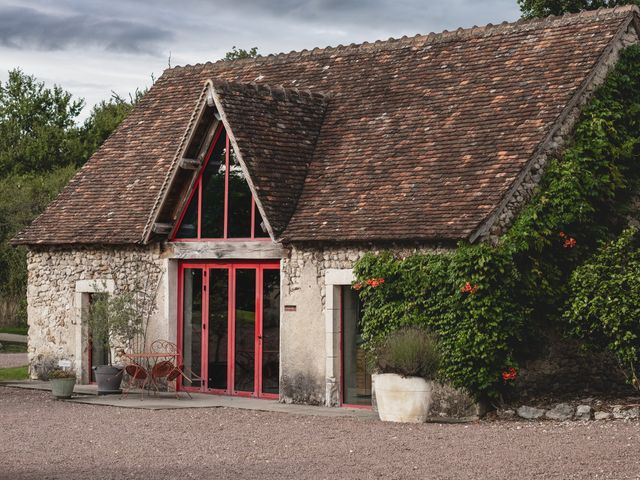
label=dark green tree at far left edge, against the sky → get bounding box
[0,69,84,176]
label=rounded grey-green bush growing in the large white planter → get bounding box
[372,327,440,380]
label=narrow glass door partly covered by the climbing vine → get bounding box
[341,287,371,405]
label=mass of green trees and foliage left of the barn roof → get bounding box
[0,69,146,323]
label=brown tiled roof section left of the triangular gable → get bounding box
[13,75,202,245]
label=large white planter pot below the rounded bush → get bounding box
[373,373,433,423]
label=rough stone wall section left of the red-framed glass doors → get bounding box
[27,246,167,381]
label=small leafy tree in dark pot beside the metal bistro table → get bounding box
[87,292,144,395]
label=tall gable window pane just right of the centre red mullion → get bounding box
[227,149,253,238]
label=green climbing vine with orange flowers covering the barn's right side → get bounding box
[354,46,640,397]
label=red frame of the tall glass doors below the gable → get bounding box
[176,260,280,400]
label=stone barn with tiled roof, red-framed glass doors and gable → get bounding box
[14,6,639,406]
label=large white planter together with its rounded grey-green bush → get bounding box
[372,327,440,423]
